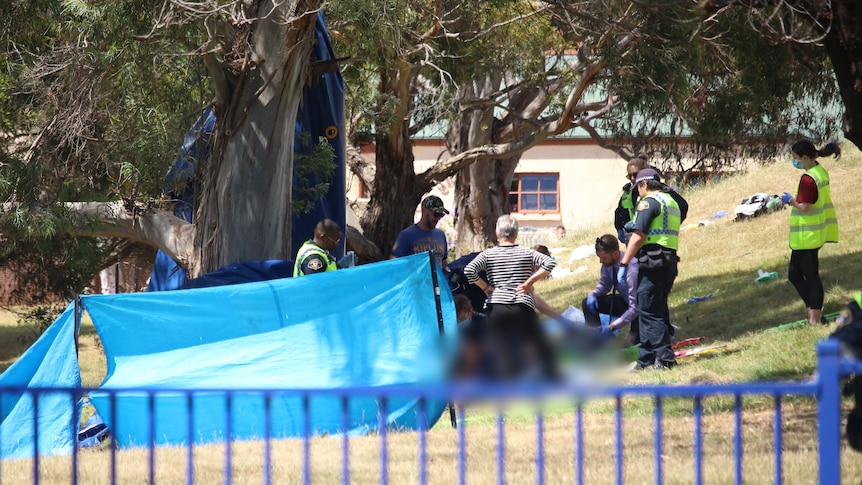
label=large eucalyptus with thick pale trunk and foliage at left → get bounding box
[0,0,322,296]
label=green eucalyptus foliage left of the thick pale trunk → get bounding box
[0,0,211,298]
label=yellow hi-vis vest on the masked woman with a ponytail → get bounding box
[790,165,838,249]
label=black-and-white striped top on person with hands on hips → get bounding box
[464,245,557,309]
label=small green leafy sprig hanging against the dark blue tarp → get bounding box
[291,132,335,216]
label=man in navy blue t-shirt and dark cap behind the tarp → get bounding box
[390,195,449,268]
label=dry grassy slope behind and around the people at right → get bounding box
[539,147,862,382]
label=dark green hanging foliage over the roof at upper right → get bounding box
[599,2,840,169]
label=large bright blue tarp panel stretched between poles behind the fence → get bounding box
[87,254,457,447]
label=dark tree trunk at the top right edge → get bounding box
[821,0,862,148]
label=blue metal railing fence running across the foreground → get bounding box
[0,341,862,484]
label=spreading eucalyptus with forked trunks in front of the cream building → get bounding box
[335,0,834,251]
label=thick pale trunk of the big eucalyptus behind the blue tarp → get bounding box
[194,0,320,277]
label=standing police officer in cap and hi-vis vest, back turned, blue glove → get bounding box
[617,168,682,369]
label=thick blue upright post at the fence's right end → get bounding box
[817,340,841,484]
